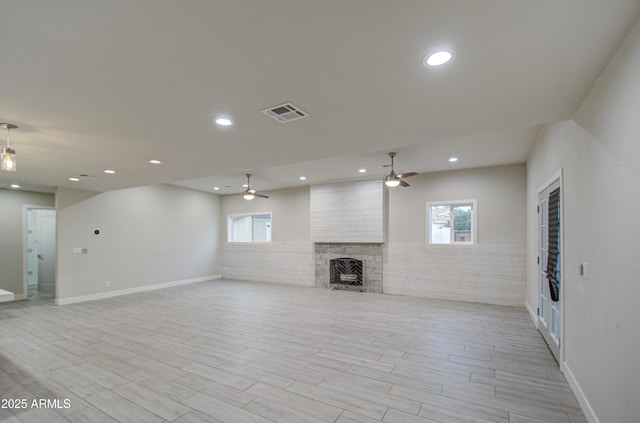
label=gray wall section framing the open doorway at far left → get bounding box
[0,189,55,298]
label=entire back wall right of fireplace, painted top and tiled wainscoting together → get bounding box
[383,165,526,306]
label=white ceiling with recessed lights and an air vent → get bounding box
[0,0,640,194]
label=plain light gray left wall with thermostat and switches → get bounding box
[56,185,222,301]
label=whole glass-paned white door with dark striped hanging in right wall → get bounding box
[538,173,564,363]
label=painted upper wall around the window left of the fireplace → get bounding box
[220,186,311,242]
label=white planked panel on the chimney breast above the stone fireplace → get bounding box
[310,181,385,243]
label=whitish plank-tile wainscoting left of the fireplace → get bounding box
[222,242,315,286]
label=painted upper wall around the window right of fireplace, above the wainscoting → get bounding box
[389,164,526,244]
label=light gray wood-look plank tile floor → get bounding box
[0,280,586,423]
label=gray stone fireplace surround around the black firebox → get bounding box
[314,242,384,294]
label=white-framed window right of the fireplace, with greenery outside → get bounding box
[427,200,477,245]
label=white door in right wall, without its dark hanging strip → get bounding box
[538,179,563,363]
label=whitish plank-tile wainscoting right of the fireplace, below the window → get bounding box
[383,242,526,307]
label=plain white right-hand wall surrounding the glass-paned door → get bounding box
[527,16,640,423]
